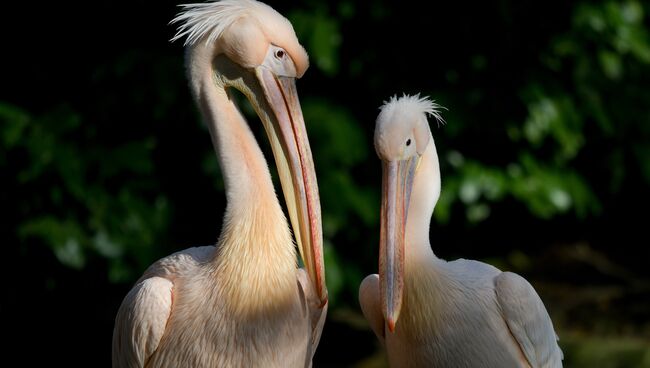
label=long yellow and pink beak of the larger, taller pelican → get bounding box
[255,66,327,306]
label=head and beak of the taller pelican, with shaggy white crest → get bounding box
[172,0,327,303]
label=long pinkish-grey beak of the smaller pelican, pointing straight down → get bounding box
[379,157,420,332]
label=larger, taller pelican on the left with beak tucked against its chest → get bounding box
[113,0,327,367]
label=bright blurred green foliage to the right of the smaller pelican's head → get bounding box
[435,1,650,226]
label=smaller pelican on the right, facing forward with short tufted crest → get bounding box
[359,95,562,368]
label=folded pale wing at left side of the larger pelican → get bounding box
[113,277,173,367]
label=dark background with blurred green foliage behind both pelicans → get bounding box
[0,0,650,367]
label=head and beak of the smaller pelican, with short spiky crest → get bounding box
[374,95,442,332]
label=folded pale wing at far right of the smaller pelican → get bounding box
[495,272,563,368]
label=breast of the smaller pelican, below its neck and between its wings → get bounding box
[374,257,529,367]
